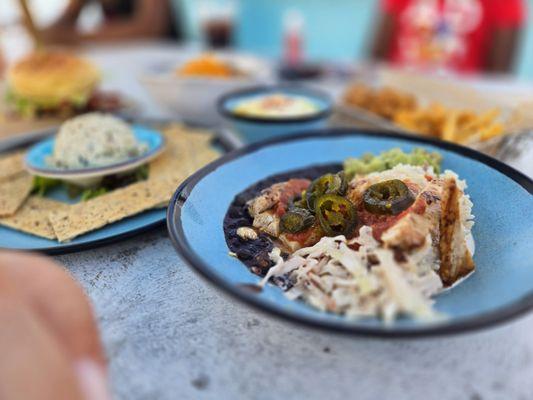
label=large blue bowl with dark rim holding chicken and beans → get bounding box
[167,130,533,336]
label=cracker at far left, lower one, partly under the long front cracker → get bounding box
[0,196,69,240]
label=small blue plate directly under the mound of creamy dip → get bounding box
[26,125,165,181]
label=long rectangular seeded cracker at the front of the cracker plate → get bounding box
[49,179,175,242]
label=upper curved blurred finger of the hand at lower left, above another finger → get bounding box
[0,252,106,368]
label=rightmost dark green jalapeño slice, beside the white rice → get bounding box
[363,179,415,215]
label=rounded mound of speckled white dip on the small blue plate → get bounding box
[48,113,148,169]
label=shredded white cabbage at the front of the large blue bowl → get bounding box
[261,226,442,322]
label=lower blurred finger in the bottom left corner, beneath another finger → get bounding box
[0,290,84,400]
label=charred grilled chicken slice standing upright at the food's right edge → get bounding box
[439,178,475,286]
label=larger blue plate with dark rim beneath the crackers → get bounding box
[0,127,234,254]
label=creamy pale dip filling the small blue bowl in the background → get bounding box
[233,93,319,118]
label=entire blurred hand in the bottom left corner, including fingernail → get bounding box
[0,252,109,400]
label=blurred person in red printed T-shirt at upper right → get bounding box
[371,0,526,73]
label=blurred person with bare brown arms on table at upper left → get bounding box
[40,0,182,44]
